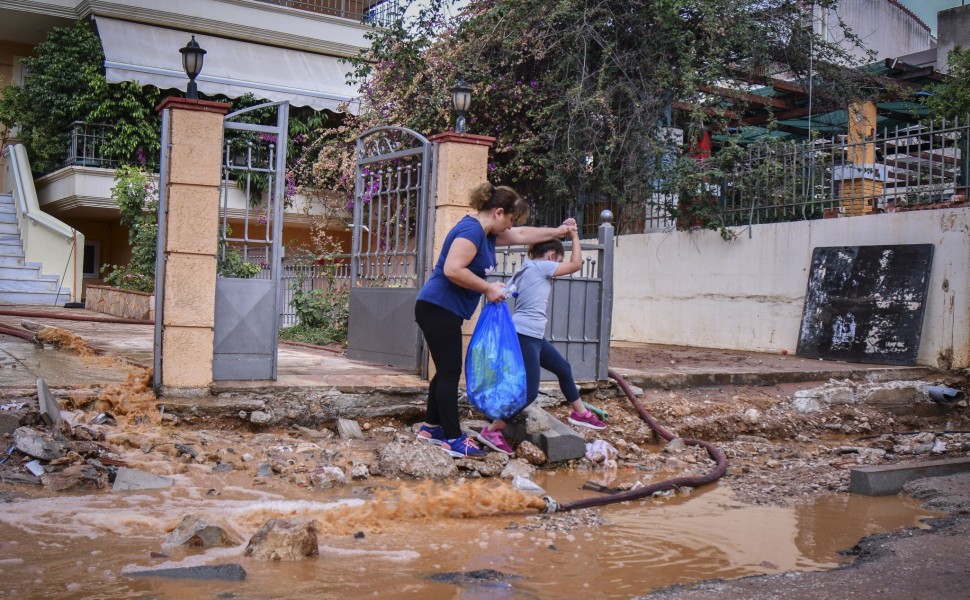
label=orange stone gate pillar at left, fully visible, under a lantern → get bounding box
[158,98,229,391]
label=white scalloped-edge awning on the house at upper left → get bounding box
[96,17,357,112]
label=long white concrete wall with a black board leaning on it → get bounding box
[612,208,970,368]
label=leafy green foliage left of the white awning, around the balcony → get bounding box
[0,21,160,174]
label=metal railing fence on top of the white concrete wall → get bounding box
[532,119,970,238]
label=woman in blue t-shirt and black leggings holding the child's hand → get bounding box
[414,182,576,457]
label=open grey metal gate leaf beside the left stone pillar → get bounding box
[212,102,290,381]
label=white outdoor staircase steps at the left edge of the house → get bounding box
[0,194,71,305]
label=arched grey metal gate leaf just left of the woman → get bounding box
[347,127,432,372]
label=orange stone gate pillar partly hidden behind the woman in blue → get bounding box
[428,131,495,378]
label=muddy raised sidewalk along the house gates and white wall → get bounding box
[0,305,932,395]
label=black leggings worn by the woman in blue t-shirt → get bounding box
[414,300,463,439]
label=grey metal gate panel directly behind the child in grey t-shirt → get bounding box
[489,211,613,381]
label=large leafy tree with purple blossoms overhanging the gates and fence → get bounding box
[328,0,872,213]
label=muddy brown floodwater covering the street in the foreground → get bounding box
[0,470,931,600]
